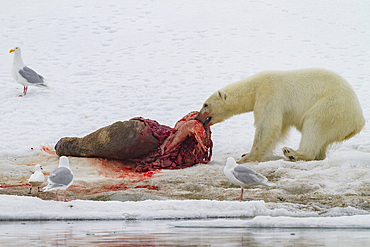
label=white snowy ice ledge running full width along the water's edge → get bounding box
[0,195,370,229]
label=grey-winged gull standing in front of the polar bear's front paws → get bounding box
[224,157,276,200]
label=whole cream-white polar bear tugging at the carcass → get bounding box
[196,69,365,164]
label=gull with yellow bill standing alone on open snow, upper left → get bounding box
[9,47,49,97]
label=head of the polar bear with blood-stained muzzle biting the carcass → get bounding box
[196,90,234,125]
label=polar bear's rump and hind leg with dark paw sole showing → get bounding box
[283,92,364,161]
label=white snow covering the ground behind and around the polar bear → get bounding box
[0,0,370,230]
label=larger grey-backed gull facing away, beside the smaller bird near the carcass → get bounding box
[44,156,73,202]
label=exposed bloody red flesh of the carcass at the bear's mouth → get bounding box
[131,112,213,172]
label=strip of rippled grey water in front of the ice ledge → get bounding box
[0,221,370,247]
